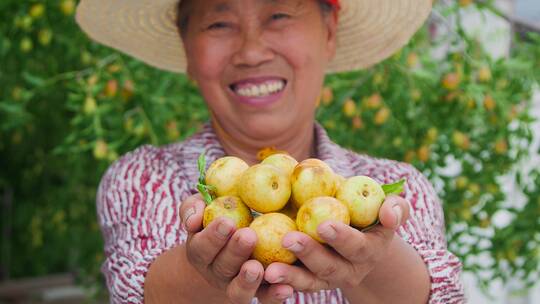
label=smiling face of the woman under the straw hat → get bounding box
[182,0,337,140]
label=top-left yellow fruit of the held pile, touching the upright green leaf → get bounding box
[205,156,249,197]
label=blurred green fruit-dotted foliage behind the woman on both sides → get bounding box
[0,0,540,294]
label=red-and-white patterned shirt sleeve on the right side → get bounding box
[392,165,465,304]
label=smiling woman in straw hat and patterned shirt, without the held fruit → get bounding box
[77,0,463,303]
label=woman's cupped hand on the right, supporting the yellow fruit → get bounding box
[264,196,409,292]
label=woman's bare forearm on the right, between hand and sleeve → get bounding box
[342,235,431,304]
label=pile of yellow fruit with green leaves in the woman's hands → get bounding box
[198,153,405,266]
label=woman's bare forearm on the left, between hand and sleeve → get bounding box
[144,245,226,304]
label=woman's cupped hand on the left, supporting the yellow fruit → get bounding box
[180,194,293,304]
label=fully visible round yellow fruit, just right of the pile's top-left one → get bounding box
[238,164,291,213]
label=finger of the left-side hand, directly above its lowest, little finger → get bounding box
[227,260,264,304]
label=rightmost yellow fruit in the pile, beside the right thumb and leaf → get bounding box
[336,176,385,229]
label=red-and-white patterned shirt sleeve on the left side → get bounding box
[96,146,187,303]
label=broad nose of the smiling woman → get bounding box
[233,30,274,67]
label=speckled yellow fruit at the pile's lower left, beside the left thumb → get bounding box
[203,196,253,228]
